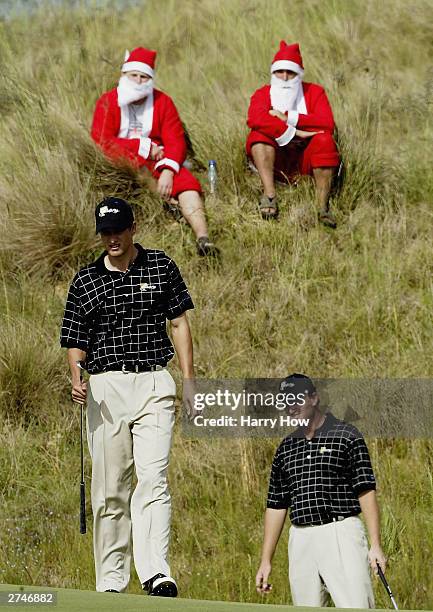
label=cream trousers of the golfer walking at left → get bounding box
[87,369,176,591]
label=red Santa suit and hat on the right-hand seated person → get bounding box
[246,41,340,180]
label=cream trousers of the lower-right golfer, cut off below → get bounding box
[289,516,374,608]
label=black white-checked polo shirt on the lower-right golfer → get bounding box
[267,413,376,525]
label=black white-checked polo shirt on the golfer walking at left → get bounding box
[60,244,194,374]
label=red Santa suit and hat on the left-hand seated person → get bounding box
[91,50,201,198]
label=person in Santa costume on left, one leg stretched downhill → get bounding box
[91,47,217,255]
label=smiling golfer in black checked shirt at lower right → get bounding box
[256,374,386,608]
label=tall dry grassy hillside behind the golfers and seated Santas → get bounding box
[0,0,433,609]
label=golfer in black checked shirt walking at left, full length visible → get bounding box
[61,198,194,597]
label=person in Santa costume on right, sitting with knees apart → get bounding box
[246,40,340,227]
